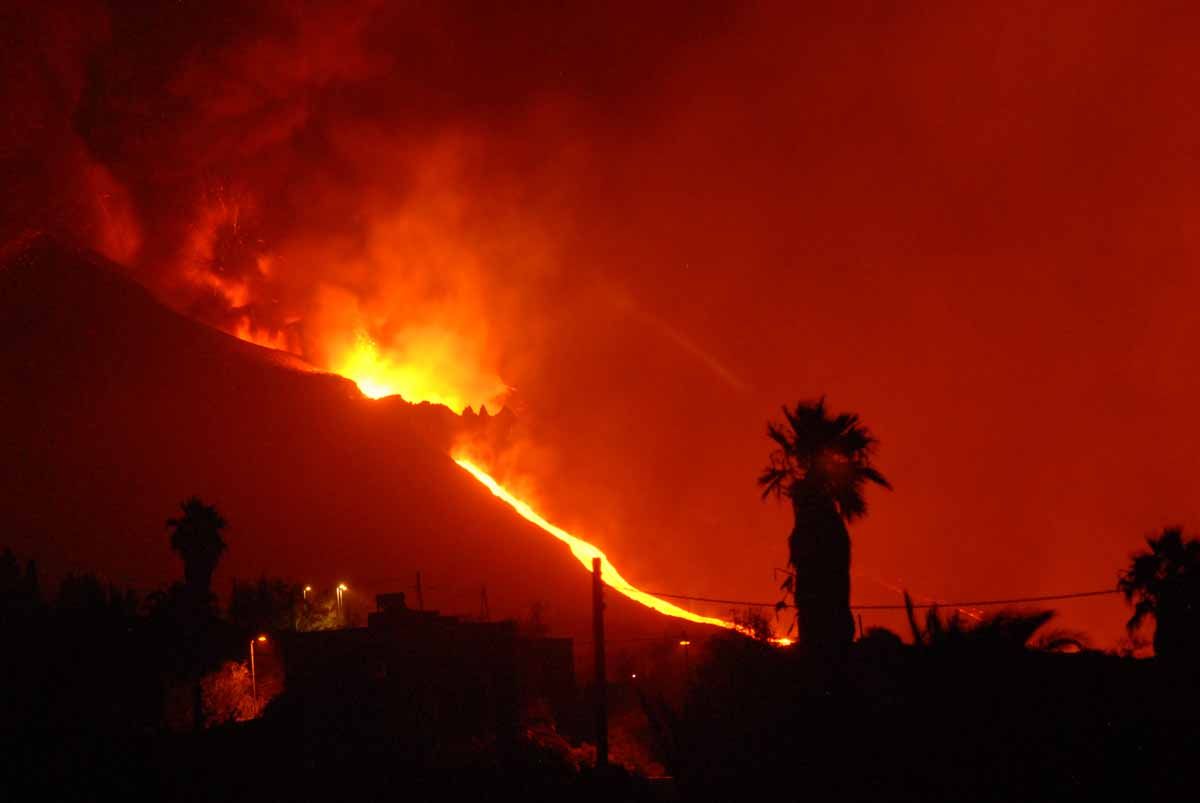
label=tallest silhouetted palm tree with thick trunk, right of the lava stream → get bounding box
[758,397,892,649]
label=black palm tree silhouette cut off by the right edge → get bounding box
[1117,527,1200,660]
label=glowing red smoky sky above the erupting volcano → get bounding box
[0,2,1200,643]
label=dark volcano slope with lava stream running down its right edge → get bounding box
[0,238,698,637]
